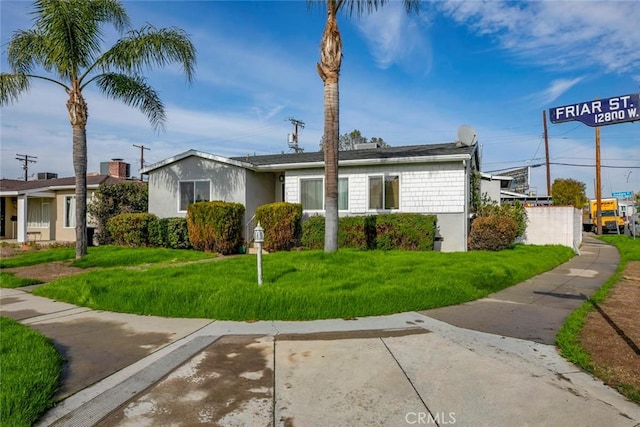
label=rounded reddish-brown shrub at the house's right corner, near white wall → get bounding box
[468,215,518,251]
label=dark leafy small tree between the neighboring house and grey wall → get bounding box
[88,181,149,245]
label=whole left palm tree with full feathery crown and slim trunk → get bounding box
[0,0,195,258]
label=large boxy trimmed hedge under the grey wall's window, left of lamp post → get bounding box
[187,201,244,255]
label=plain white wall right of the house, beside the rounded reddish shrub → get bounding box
[523,206,582,253]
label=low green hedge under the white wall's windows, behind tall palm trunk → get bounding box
[302,213,436,251]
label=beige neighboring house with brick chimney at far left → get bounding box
[0,159,126,243]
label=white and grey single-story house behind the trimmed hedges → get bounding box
[141,142,479,252]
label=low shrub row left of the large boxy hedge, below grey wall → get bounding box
[107,213,191,249]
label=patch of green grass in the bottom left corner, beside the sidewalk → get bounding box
[0,317,62,427]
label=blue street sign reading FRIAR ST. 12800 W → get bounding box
[549,93,640,127]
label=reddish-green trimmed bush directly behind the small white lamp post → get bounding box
[256,202,302,252]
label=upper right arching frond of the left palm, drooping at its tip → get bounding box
[98,25,196,81]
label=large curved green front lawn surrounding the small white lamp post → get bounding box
[34,245,573,320]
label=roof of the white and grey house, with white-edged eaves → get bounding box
[141,142,477,173]
